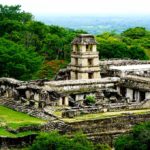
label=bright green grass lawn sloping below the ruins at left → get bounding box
[0,106,47,137]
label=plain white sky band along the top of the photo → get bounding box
[0,0,150,16]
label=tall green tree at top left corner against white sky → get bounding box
[0,4,33,37]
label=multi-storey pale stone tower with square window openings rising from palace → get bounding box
[68,34,100,80]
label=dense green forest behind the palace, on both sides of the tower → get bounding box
[0,5,150,80]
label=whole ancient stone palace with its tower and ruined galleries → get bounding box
[0,34,150,116]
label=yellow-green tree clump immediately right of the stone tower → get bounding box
[96,33,147,60]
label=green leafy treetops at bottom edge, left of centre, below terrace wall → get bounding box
[30,132,94,150]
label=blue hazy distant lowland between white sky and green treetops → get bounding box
[36,15,150,34]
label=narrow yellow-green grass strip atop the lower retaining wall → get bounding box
[62,109,150,122]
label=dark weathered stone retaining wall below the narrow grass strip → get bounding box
[66,113,150,146]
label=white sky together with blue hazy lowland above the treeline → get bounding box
[0,0,150,34]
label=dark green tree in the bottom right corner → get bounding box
[114,122,150,150]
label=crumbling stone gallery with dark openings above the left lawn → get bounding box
[0,78,62,108]
